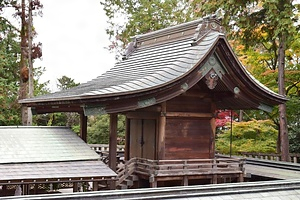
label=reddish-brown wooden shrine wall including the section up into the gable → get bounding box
[164,89,214,159]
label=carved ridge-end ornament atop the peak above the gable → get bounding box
[191,14,225,46]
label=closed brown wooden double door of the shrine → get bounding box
[129,119,156,159]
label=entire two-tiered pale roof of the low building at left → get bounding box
[0,126,116,184]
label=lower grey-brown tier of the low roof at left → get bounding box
[0,160,116,185]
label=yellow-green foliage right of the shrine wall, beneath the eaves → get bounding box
[216,120,278,155]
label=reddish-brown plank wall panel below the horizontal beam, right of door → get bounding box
[165,117,212,159]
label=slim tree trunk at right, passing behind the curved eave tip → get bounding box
[278,34,290,161]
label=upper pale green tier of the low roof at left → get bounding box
[0,126,99,164]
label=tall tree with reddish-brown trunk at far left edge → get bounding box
[0,0,42,124]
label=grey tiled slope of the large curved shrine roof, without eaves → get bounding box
[20,20,220,103]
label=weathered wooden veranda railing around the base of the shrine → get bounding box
[117,158,244,185]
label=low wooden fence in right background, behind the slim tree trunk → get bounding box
[240,152,300,163]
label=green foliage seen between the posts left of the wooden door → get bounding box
[87,115,125,144]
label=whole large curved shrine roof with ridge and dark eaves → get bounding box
[20,16,286,113]
